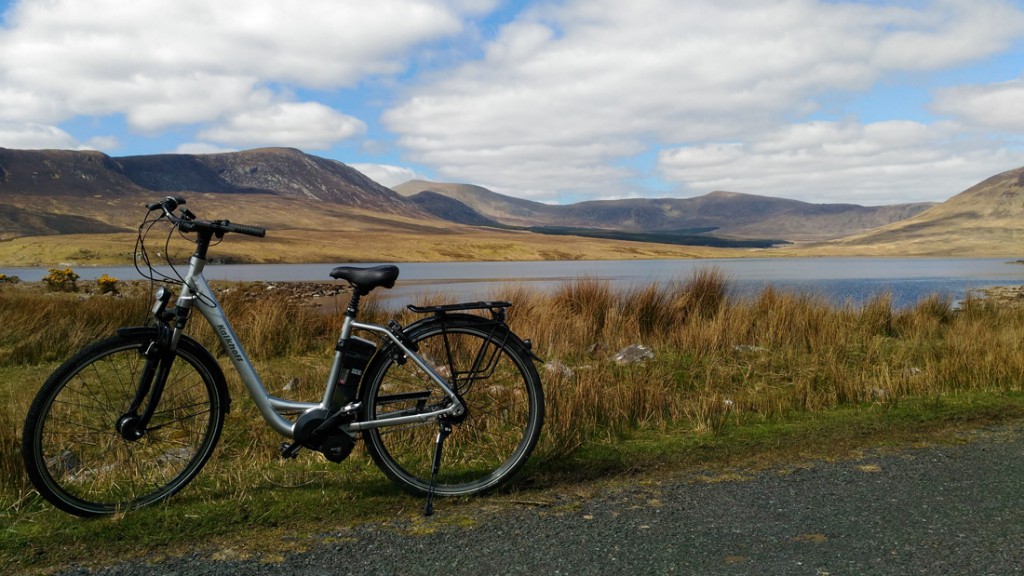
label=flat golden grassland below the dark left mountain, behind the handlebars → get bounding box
[0,194,748,266]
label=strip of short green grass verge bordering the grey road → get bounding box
[0,393,1024,573]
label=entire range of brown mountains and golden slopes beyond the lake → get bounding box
[0,148,1024,258]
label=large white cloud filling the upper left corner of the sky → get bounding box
[0,0,473,132]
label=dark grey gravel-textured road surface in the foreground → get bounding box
[59,426,1024,576]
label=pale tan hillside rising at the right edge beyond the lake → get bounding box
[814,168,1024,256]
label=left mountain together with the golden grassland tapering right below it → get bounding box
[0,149,727,266]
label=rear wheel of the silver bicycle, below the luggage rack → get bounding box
[362,320,544,496]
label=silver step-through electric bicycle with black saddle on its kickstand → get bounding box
[22,197,544,517]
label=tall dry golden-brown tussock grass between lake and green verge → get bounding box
[0,270,1024,569]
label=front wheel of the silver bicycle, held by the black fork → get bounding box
[22,334,226,517]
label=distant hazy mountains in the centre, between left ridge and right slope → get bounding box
[393,180,933,242]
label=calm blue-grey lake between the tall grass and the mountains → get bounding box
[0,257,1024,307]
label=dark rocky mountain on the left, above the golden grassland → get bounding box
[0,148,427,239]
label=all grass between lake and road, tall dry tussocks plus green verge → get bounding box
[0,270,1024,570]
